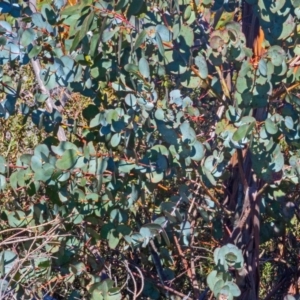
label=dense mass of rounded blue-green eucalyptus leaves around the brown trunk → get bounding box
[0,0,300,299]
